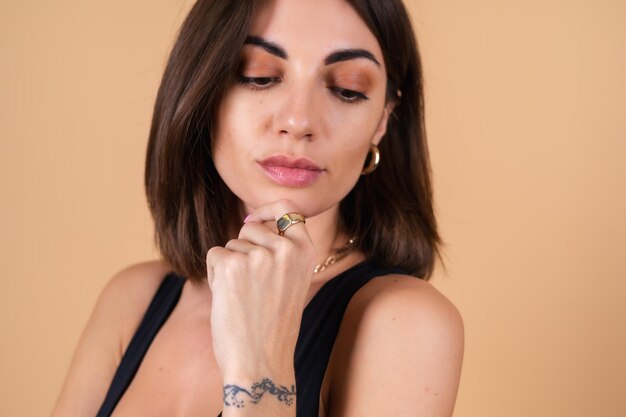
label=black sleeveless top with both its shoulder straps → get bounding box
[97,261,405,417]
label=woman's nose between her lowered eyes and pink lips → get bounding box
[274,86,316,140]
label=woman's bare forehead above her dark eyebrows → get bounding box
[250,0,383,62]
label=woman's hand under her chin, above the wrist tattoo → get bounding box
[206,200,315,379]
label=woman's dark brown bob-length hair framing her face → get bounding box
[145,0,441,282]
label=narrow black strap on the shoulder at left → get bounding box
[96,272,185,417]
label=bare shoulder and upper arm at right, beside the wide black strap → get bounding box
[329,274,464,417]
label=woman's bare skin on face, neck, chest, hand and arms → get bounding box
[52,0,463,417]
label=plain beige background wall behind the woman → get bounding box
[0,0,626,417]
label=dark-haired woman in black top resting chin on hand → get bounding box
[53,0,463,417]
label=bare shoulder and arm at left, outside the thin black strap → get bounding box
[52,261,170,417]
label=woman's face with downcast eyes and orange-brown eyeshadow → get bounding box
[213,0,389,217]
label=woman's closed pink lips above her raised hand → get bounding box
[259,155,324,187]
